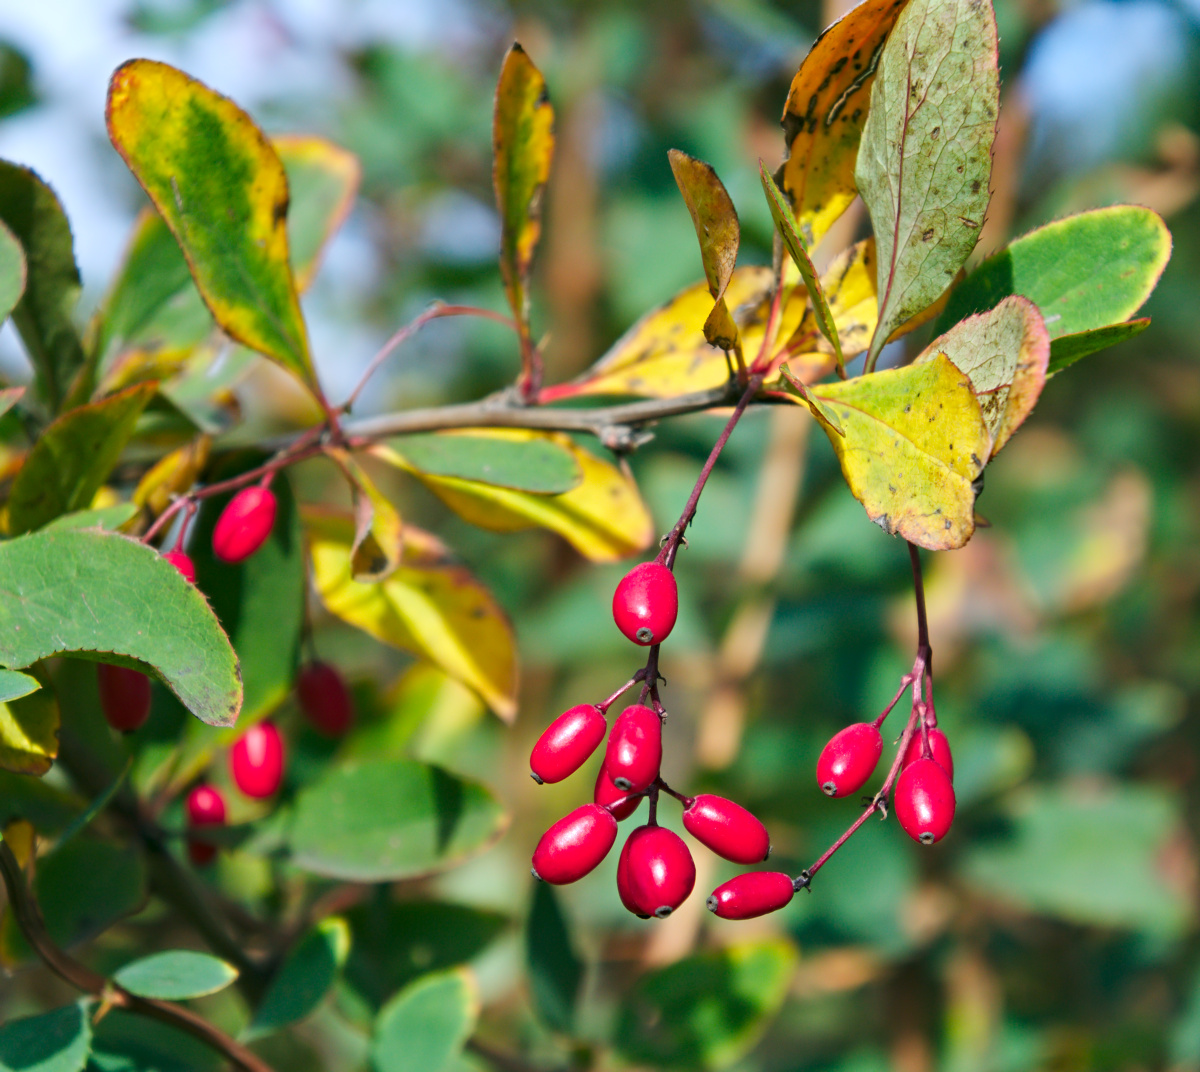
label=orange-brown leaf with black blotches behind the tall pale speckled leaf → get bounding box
[776,0,906,246]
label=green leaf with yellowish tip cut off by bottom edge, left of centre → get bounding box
[371,969,479,1072]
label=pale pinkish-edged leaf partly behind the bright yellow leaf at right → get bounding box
[914,295,1050,459]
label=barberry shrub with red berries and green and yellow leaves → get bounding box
[0,0,1170,1070]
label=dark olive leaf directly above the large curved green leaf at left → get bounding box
[8,383,155,534]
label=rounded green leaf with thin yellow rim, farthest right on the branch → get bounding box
[936,205,1171,343]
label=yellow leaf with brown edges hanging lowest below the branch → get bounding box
[304,510,517,721]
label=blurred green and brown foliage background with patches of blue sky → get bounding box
[0,0,1200,1072]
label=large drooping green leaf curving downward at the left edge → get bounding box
[0,529,241,725]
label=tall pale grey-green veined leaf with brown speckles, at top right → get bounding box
[854,0,1000,369]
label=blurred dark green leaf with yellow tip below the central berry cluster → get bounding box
[614,940,796,1070]
